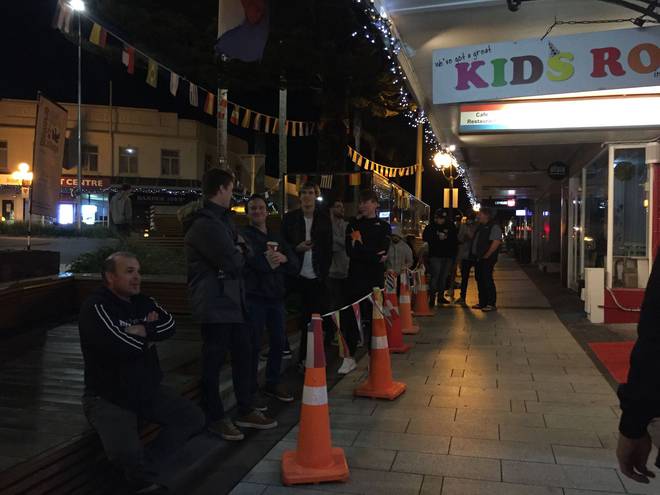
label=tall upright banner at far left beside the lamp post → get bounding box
[30,95,67,217]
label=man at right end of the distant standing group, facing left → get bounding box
[470,208,502,312]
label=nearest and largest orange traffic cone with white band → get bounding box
[282,314,349,485]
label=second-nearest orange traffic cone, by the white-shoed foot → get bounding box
[353,287,406,400]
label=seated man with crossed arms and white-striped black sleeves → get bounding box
[78,252,204,493]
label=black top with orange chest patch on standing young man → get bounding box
[346,218,392,291]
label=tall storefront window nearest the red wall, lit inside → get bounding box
[612,148,649,288]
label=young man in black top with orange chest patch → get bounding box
[339,190,392,374]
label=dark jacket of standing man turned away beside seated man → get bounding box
[183,201,247,323]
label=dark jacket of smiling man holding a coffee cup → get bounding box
[241,226,300,300]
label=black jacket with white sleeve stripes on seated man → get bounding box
[78,287,175,410]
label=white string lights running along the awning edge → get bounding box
[351,0,479,208]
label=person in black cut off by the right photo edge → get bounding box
[616,255,660,483]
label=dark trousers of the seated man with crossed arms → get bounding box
[83,386,204,489]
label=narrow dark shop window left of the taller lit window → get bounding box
[583,153,608,268]
